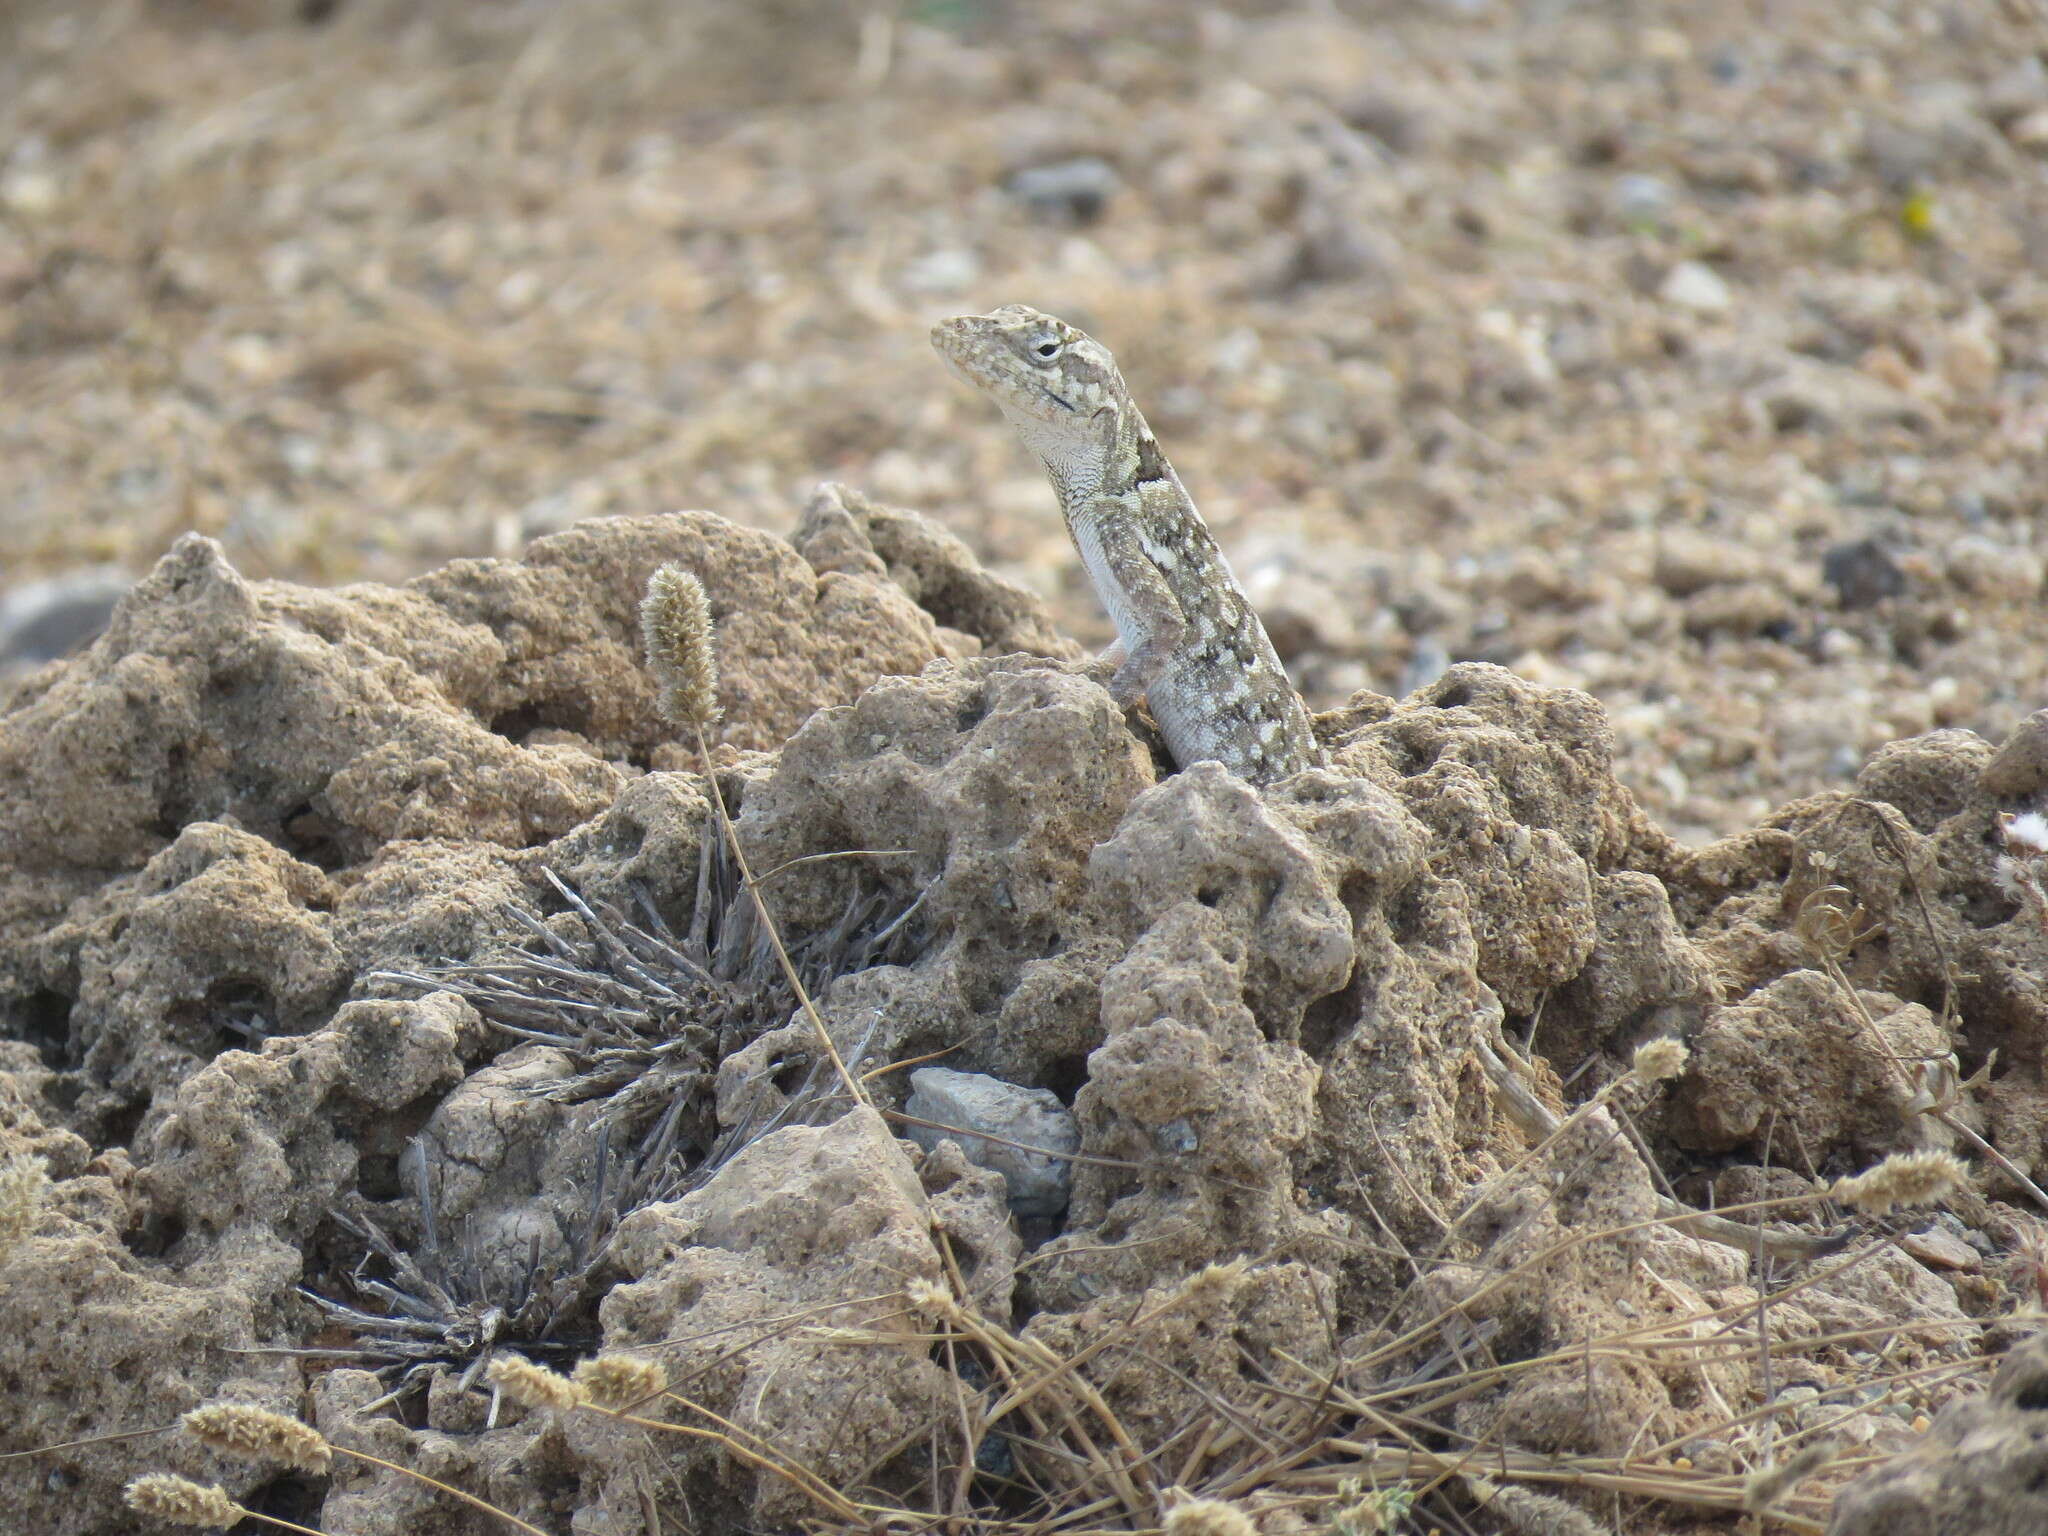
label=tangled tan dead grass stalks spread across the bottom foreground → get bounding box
[83,1122,1995,1536]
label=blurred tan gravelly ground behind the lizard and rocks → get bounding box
[0,0,2048,838]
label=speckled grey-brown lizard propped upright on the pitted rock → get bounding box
[932,303,1321,784]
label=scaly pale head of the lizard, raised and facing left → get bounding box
[932,303,1124,428]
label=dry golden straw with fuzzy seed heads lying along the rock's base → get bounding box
[92,1212,1987,1536]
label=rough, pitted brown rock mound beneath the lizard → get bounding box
[0,505,2048,1536]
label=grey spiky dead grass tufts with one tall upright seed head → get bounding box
[307,565,924,1393]
